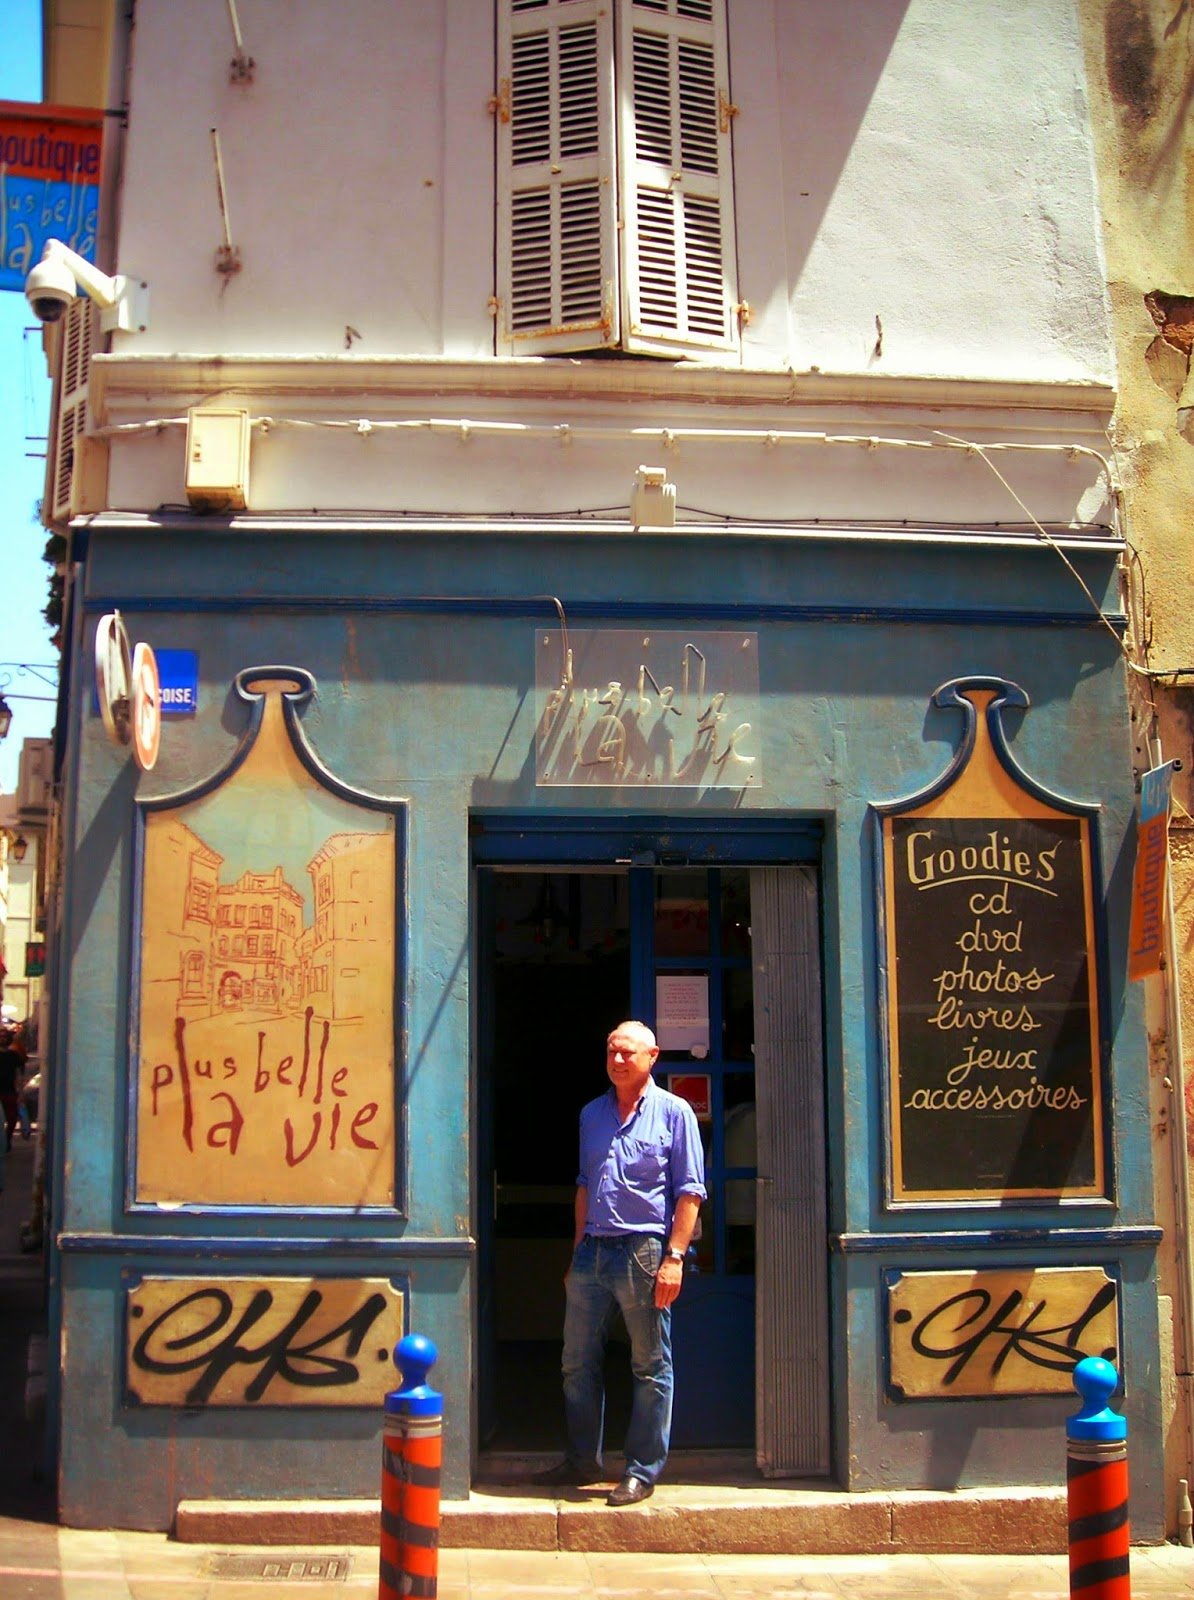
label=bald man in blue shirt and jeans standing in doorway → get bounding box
[539,1022,706,1506]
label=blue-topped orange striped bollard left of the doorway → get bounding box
[378,1333,443,1600]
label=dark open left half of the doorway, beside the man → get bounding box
[479,867,631,1451]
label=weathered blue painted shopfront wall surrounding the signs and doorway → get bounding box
[54,517,1160,1534]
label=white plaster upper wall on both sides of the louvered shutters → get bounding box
[114,0,1112,382]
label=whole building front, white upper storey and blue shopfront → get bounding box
[34,0,1168,1538]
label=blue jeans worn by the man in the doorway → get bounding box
[563,1234,672,1483]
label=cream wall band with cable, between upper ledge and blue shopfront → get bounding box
[107,400,1112,526]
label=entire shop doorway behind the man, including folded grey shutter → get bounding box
[472,818,829,1477]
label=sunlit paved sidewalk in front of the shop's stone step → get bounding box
[0,1520,1194,1600]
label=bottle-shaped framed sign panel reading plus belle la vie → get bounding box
[125,666,408,1216]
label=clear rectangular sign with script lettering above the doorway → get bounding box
[535,629,762,789]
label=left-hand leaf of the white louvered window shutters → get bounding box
[496,0,619,355]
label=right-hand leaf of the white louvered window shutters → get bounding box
[618,0,739,354]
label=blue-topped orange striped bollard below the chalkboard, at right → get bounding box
[1066,1355,1132,1600]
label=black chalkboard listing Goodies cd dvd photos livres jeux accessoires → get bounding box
[883,814,1103,1200]
